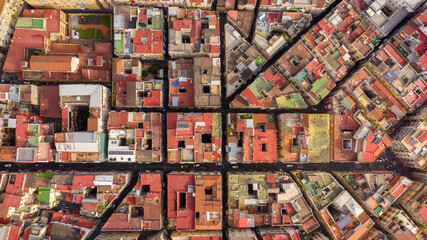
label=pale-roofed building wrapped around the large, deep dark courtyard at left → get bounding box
[55,84,110,162]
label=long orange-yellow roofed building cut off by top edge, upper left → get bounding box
[25,0,101,10]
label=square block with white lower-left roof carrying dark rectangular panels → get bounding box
[108,112,162,162]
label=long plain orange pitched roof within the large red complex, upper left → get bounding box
[30,55,73,72]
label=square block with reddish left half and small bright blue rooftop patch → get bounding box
[169,57,221,108]
